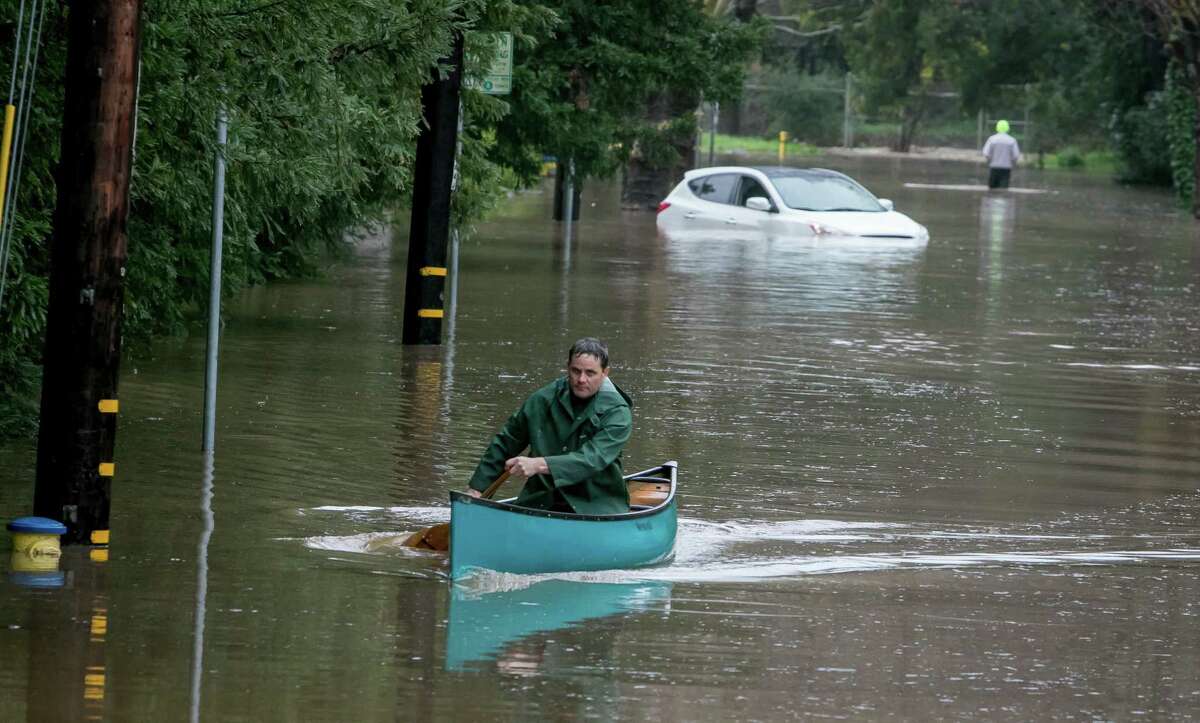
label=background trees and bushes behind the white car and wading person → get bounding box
[739,0,1200,199]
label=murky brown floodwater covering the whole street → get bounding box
[0,157,1200,721]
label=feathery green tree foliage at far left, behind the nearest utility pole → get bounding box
[0,0,506,434]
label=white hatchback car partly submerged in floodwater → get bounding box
[658,166,929,244]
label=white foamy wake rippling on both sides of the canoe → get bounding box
[297,507,1200,592]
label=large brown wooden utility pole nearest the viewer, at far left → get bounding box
[34,0,142,544]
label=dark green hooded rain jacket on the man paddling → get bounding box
[470,376,634,514]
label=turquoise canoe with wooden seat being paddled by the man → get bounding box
[450,462,678,579]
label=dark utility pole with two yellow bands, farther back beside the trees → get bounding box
[401,32,462,343]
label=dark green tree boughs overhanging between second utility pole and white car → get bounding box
[496,0,762,183]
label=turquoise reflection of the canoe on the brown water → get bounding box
[445,580,671,670]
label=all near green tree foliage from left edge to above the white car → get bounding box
[0,0,756,434]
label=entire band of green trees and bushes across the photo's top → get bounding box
[7,0,1200,436]
